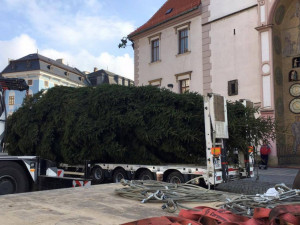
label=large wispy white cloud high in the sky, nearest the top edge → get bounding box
[6,0,134,46]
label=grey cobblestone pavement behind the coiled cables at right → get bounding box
[216,168,299,195]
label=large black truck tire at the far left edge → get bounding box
[0,162,30,195]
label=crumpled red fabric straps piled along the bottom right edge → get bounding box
[122,205,300,225]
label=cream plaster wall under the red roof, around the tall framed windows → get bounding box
[138,16,203,93]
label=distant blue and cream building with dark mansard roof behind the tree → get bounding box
[1,54,133,115]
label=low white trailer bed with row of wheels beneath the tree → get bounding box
[60,163,223,185]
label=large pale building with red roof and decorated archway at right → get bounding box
[128,0,300,165]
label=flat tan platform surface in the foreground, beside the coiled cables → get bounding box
[0,184,227,225]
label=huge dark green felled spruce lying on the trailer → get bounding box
[6,85,274,164]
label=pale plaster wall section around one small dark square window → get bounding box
[210,6,261,103]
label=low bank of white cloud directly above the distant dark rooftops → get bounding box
[0,34,134,79]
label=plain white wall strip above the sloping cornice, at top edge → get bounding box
[209,0,257,21]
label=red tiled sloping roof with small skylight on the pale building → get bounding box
[128,0,201,37]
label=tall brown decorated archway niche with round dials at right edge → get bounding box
[269,0,300,165]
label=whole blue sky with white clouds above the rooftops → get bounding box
[0,0,165,79]
